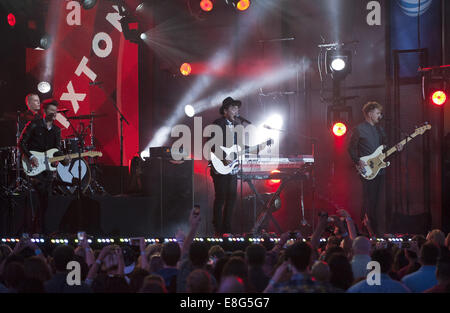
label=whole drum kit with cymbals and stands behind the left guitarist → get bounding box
[0,112,106,195]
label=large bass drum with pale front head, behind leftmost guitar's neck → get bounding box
[56,159,91,194]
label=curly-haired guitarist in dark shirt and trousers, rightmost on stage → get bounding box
[348,101,403,233]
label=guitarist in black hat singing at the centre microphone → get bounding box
[210,97,242,236]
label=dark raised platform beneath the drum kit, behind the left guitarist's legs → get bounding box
[0,194,190,237]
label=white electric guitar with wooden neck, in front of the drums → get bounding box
[22,149,103,176]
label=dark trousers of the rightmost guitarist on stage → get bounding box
[361,175,384,234]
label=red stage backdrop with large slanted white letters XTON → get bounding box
[27,0,139,165]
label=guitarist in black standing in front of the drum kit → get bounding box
[18,99,69,233]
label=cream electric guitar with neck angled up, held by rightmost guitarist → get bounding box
[357,124,431,180]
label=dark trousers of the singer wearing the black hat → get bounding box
[211,171,237,234]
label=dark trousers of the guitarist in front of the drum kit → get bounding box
[25,171,53,233]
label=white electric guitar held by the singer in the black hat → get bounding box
[210,139,273,175]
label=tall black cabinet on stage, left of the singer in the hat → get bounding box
[142,157,194,237]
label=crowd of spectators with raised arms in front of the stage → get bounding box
[0,210,450,293]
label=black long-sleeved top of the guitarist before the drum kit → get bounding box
[18,118,61,157]
